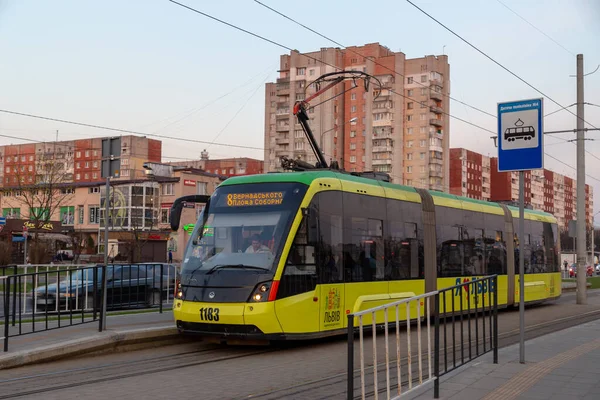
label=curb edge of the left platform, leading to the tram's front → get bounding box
[0,326,181,370]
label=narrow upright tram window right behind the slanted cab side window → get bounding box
[316,191,344,283]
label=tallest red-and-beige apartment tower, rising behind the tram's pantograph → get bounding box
[264,43,450,190]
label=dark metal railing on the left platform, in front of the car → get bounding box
[0,263,178,351]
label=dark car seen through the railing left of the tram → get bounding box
[33,264,174,311]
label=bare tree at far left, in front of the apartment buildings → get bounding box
[6,143,75,263]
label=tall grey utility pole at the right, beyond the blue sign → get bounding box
[576,54,587,304]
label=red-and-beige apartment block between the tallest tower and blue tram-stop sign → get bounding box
[450,148,491,200]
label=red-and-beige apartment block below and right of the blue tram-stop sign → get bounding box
[490,157,593,228]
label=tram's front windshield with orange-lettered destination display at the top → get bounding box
[182,183,306,275]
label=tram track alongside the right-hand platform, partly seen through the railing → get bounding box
[245,304,600,400]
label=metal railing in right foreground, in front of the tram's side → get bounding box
[347,275,498,399]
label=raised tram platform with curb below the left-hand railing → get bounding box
[0,310,180,370]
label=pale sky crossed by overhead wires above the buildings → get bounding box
[0,0,600,212]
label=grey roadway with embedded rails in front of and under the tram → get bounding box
[0,291,600,400]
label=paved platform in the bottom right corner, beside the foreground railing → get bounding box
[410,320,600,400]
